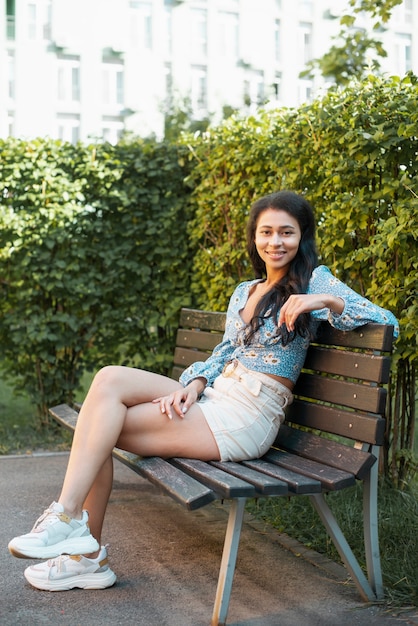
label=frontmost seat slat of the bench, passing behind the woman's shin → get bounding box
[49,404,216,510]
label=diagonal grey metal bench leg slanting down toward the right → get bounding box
[309,493,376,602]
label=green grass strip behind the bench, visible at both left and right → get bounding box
[0,370,418,608]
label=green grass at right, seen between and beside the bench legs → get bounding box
[247,484,418,609]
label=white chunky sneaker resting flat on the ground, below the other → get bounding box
[25,546,116,591]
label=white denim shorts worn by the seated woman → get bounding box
[199,359,293,461]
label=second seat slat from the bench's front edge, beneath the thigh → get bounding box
[170,457,257,499]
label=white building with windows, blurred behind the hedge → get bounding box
[0,0,418,142]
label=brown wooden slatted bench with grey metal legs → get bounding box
[50,309,393,626]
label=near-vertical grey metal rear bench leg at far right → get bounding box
[363,448,384,600]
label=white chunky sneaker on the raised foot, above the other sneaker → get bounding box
[8,502,100,559]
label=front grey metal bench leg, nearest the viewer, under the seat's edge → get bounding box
[211,498,247,626]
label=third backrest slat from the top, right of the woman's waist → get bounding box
[293,372,386,414]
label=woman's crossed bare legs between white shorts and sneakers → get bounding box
[59,366,219,543]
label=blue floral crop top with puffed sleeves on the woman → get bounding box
[180,265,399,386]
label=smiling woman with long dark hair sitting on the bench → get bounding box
[9,191,397,590]
